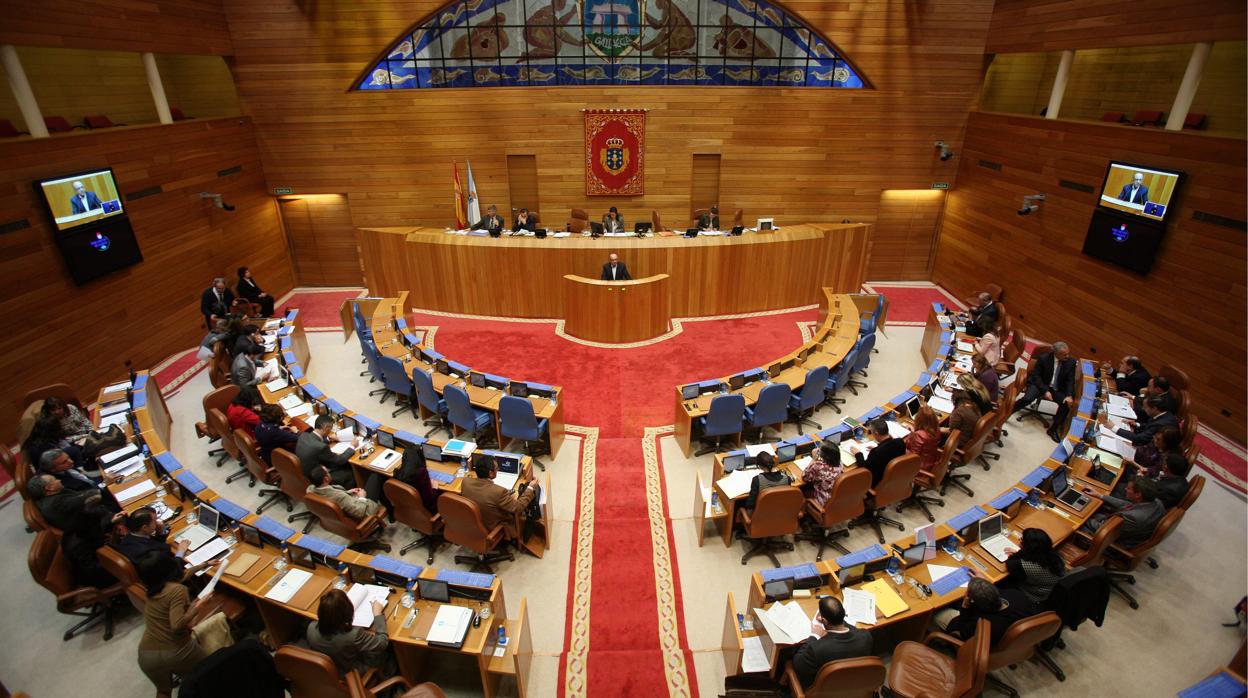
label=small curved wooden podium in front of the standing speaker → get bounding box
[563,273,671,345]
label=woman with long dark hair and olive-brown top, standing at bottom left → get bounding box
[135,553,225,698]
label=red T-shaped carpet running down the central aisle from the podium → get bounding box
[411,310,815,698]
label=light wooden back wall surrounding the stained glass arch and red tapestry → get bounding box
[219,0,992,250]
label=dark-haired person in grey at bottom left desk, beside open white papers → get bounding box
[306,589,393,676]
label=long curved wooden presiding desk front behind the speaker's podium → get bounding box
[359,224,871,317]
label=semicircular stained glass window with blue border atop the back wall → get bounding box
[353,0,870,90]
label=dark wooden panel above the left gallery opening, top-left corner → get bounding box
[0,0,231,55]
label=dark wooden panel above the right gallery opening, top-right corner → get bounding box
[986,0,1248,54]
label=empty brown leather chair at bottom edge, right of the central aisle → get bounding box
[885,618,992,698]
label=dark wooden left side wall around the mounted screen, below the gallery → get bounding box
[0,119,292,437]
